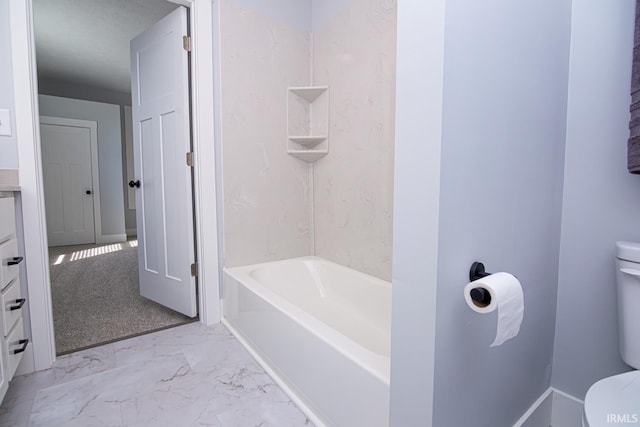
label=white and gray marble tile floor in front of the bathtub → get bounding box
[0,323,312,427]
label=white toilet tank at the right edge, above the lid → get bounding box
[616,242,640,369]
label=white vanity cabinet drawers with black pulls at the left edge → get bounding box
[0,192,29,401]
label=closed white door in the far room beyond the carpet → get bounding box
[40,117,99,246]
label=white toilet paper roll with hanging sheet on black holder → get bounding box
[464,272,524,347]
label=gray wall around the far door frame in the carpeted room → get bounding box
[39,95,125,239]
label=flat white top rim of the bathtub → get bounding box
[223,257,391,386]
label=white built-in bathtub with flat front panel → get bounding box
[222,257,391,427]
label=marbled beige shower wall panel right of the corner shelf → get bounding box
[313,0,397,281]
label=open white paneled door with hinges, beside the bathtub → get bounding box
[130,6,197,317]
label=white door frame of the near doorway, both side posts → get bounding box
[9,0,221,373]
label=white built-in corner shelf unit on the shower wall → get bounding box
[287,86,329,163]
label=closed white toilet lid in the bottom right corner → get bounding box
[584,371,640,427]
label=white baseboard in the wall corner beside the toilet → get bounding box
[513,387,584,427]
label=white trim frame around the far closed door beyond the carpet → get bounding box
[39,116,102,244]
